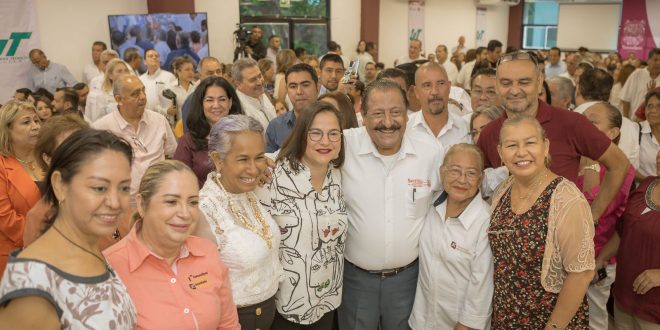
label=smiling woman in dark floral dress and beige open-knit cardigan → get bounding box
[488,116,595,329]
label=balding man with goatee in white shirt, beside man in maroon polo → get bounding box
[407,62,470,150]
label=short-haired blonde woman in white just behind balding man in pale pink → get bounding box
[85,58,129,123]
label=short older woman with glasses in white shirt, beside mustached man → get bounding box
[409,143,493,329]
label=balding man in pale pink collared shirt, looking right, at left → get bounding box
[92,75,176,207]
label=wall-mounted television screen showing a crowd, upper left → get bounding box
[108,13,209,70]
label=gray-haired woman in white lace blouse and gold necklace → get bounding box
[199,115,281,329]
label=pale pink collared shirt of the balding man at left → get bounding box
[92,110,176,200]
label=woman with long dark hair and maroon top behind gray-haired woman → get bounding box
[173,76,243,187]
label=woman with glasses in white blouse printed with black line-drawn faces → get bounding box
[258,101,348,330]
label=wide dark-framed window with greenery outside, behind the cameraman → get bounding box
[239,0,330,56]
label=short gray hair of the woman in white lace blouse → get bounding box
[209,114,264,159]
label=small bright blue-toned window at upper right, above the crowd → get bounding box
[522,1,559,49]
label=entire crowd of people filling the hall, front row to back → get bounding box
[0,22,660,330]
